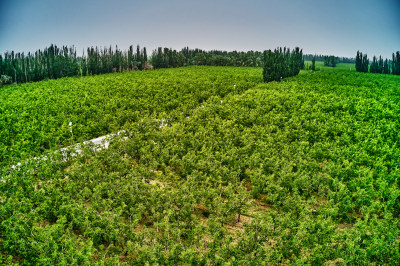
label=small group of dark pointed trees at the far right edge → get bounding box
[355,51,400,75]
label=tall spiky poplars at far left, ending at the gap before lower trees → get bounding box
[0,44,148,83]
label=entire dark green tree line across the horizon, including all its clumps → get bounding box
[0,44,378,84]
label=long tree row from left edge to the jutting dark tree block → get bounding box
[0,44,263,84]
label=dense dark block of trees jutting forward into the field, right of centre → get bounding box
[263,47,304,82]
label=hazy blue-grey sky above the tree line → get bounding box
[0,0,400,57]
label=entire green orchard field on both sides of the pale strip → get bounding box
[0,64,400,265]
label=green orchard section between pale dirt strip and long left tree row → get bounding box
[0,67,261,166]
